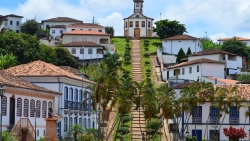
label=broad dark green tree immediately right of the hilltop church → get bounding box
[153,19,187,39]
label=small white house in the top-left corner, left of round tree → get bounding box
[0,14,23,33]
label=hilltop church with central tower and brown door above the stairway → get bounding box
[123,0,154,37]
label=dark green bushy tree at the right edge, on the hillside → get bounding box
[221,38,249,60]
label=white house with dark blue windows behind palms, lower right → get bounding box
[179,84,250,141]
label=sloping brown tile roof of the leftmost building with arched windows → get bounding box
[0,70,60,94]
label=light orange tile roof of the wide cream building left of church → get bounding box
[63,30,111,36]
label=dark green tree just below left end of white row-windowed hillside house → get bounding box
[55,47,76,68]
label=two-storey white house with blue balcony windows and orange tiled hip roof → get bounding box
[5,61,95,139]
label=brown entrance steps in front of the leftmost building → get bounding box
[11,118,35,141]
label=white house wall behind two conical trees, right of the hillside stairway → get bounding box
[162,40,202,55]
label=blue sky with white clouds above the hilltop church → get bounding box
[0,0,250,41]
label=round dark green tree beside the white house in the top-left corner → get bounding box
[21,19,39,35]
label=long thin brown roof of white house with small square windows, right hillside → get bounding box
[168,58,225,69]
